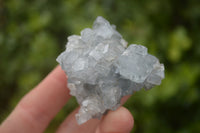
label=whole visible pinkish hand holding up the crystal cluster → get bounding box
[0,66,134,133]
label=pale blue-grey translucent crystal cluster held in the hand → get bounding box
[57,17,164,124]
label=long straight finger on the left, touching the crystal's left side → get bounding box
[0,66,70,133]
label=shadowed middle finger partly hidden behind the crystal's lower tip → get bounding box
[57,96,130,133]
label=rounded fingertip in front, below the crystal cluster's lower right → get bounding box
[95,107,134,133]
